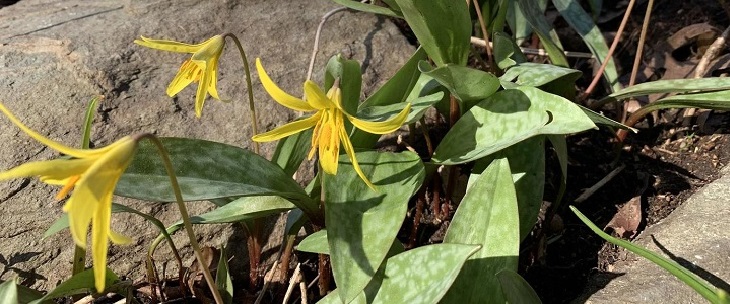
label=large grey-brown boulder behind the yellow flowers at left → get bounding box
[0,0,414,289]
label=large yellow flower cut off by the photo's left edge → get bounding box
[0,103,137,292]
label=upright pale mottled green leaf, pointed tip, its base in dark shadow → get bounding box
[443,158,520,303]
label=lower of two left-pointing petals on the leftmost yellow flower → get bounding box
[0,158,95,185]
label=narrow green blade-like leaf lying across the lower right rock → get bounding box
[569,206,727,303]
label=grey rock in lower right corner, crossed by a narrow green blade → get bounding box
[576,167,730,303]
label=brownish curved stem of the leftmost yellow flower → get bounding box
[138,133,223,304]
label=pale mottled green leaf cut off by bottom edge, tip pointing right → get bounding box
[318,244,479,304]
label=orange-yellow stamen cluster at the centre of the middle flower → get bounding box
[317,113,345,175]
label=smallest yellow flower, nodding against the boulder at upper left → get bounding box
[134,35,226,118]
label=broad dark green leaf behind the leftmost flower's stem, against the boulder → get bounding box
[115,138,318,212]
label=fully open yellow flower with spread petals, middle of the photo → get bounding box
[253,58,411,189]
